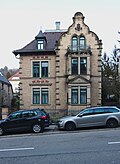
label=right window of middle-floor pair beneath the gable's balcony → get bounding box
[80,57,87,75]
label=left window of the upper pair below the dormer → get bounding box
[33,62,40,77]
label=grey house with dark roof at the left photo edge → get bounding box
[0,72,13,110]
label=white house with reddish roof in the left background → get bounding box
[8,71,20,95]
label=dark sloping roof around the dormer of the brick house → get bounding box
[13,31,64,55]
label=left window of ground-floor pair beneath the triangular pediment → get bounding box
[71,87,78,104]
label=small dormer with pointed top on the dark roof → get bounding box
[35,30,47,50]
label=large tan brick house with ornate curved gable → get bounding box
[13,12,102,115]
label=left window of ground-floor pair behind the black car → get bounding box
[33,88,40,104]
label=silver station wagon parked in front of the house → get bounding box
[58,106,120,131]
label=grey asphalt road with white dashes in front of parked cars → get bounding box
[0,128,120,164]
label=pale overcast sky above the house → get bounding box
[0,0,120,69]
